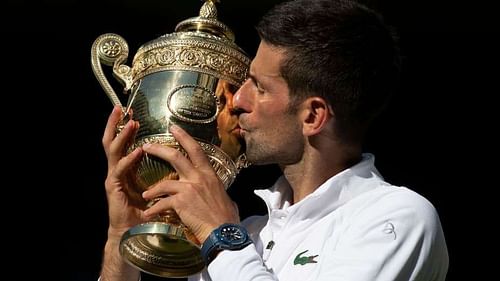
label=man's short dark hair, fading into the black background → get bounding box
[256,0,400,142]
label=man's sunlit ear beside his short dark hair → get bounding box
[302,97,333,136]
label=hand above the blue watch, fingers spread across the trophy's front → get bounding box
[142,125,239,243]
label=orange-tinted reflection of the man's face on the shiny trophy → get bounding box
[215,80,243,160]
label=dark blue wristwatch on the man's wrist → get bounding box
[201,223,252,266]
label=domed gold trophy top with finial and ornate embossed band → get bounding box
[132,0,250,86]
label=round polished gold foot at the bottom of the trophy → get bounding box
[120,222,205,278]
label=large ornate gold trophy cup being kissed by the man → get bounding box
[91,0,250,277]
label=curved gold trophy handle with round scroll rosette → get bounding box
[91,33,132,107]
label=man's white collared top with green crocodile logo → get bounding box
[189,154,448,281]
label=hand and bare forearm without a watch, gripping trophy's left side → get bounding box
[100,106,145,281]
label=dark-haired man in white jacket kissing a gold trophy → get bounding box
[101,0,448,281]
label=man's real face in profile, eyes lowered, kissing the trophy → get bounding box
[233,42,304,165]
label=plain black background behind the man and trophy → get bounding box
[0,0,500,281]
